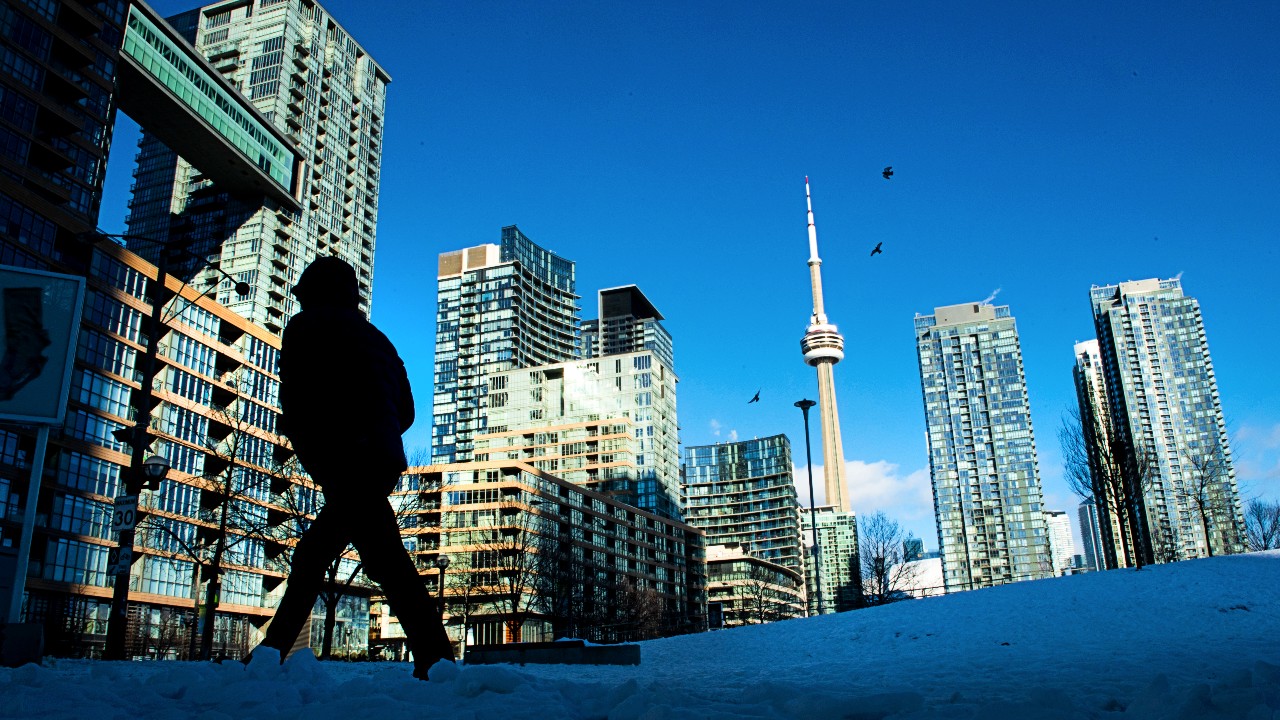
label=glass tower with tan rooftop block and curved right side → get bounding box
[431,225,581,465]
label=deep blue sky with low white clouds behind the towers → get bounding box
[101,0,1280,548]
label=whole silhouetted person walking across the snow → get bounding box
[252,258,453,679]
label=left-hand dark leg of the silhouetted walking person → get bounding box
[262,503,358,660]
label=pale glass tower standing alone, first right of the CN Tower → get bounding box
[915,302,1052,592]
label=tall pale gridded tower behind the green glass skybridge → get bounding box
[128,0,390,333]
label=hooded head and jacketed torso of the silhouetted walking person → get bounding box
[279,258,413,495]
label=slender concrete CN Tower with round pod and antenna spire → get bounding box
[800,177,852,512]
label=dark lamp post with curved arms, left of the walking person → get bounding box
[86,232,250,660]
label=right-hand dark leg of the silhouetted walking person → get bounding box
[352,489,453,678]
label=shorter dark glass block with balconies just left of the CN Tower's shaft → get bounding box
[681,436,804,574]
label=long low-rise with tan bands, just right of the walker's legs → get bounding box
[392,460,707,650]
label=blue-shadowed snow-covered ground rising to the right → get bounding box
[0,551,1280,720]
